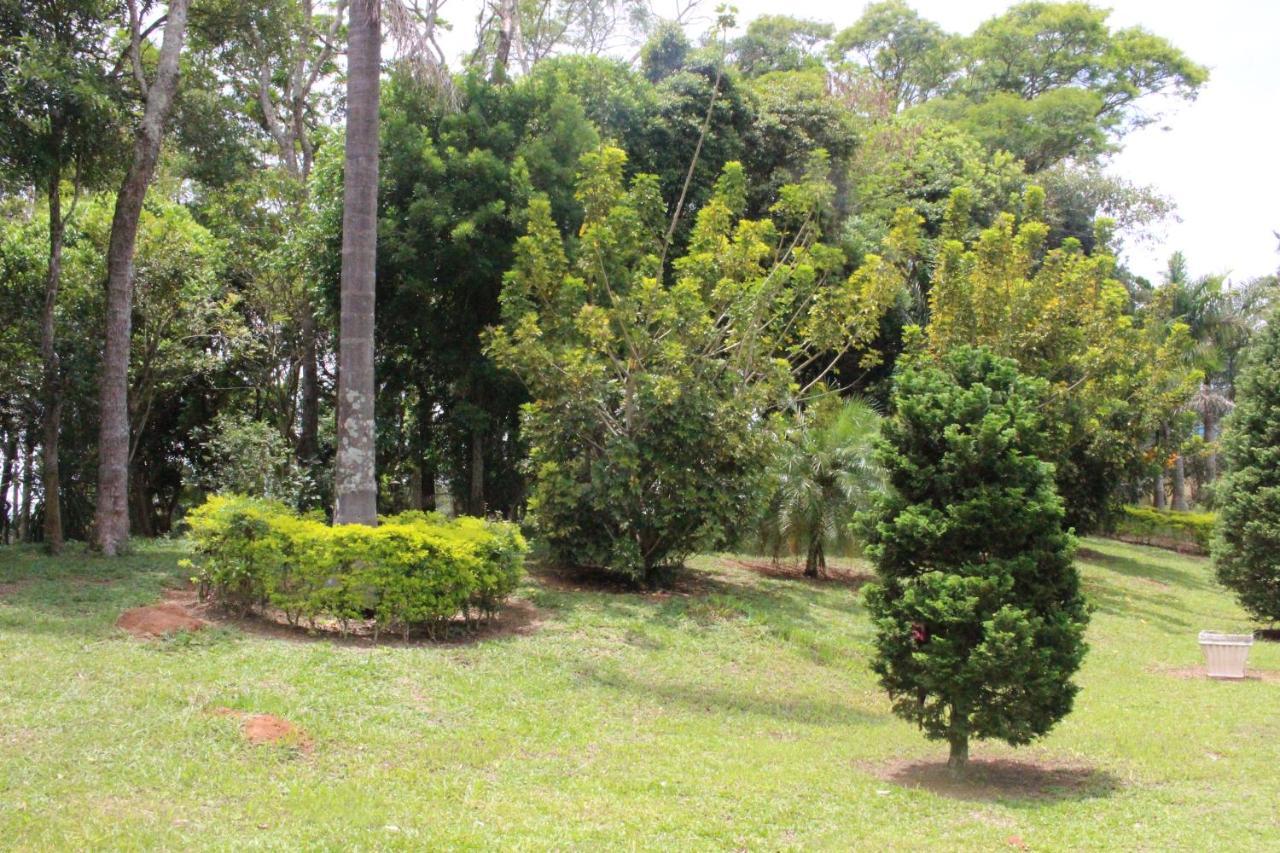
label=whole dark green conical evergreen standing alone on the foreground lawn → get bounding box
[864,347,1088,772]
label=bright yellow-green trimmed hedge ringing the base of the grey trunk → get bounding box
[187,496,526,637]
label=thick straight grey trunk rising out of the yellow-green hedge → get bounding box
[334,0,381,525]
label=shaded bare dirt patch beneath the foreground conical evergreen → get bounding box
[867,758,1119,802]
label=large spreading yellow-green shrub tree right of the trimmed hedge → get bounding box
[489,147,902,581]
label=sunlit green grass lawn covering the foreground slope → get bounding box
[0,539,1280,850]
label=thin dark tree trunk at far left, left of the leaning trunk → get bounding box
[40,167,67,553]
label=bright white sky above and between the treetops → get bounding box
[432,0,1280,280]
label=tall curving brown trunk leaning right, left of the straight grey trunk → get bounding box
[95,0,189,556]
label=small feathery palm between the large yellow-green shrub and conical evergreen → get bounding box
[762,398,881,578]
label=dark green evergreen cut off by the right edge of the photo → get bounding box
[1213,315,1280,622]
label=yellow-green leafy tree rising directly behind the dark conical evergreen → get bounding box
[924,187,1199,532]
